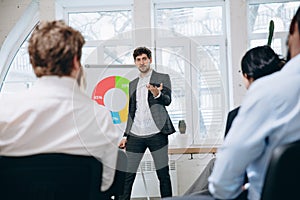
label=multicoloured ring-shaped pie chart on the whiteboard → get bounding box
[92,76,129,124]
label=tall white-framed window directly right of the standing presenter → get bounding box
[154,1,228,145]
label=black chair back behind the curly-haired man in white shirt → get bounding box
[0,153,103,200]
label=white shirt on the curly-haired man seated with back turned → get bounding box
[0,76,120,190]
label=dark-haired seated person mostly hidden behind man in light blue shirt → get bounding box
[185,46,285,198]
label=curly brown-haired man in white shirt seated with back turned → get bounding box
[0,21,119,191]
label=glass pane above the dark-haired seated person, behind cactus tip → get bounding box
[248,1,300,33]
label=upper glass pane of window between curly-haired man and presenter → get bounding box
[69,10,132,41]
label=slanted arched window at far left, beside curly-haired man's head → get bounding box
[0,1,39,93]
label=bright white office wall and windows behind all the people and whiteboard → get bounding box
[0,0,300,198]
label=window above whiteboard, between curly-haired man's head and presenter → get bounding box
[66,6,133,65]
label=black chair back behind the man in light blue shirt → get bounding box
[261,141,300,200]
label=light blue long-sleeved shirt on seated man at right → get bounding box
[208,55,300,200]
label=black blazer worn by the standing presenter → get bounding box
[124,70,175,136]
